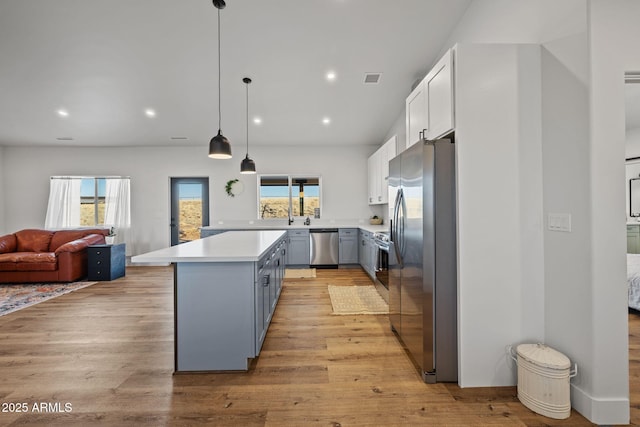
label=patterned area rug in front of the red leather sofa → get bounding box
[0,281,98,316]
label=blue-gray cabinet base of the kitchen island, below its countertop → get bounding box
[174,237,287,372]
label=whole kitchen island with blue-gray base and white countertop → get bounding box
[131,230,286,372]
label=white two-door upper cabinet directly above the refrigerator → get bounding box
[405,50,454,148]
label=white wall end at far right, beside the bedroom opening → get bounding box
[575,0,640,424]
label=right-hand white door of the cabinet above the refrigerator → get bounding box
[425,50,454,139]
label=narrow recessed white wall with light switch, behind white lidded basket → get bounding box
[542,28,595,412]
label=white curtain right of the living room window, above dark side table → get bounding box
[104,178,131,253]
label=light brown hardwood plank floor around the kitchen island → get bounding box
[0,267,640,426]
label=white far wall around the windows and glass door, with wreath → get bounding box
[0,146,376,255]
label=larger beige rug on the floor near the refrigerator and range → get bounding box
[328,285,389,315]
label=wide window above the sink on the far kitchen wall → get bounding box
[258,175,321,219]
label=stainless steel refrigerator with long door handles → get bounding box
[388,138,458,383]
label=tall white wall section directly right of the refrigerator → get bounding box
[455,44,544,387]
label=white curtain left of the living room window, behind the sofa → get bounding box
[44,177,81,229]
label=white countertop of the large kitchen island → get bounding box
[131,230,285,263]
